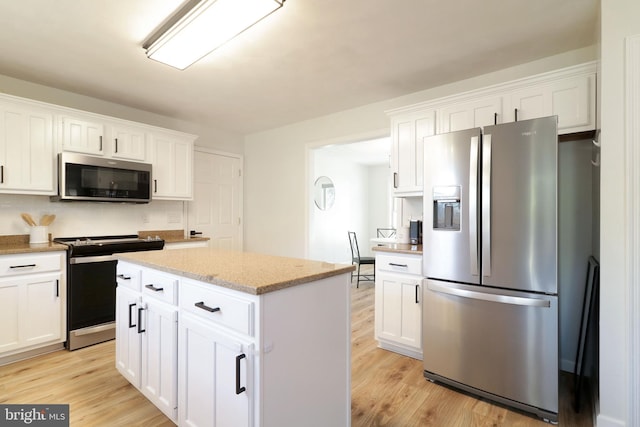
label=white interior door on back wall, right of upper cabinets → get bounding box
[188,147,242,250]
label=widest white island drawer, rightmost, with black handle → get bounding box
[180,281,253,336]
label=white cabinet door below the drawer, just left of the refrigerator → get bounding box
[375,271,422,351]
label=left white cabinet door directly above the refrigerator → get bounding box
[438,96,503,133]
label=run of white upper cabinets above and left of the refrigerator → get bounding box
[387,63,596,197]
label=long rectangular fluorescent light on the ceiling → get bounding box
[143,0,285,70]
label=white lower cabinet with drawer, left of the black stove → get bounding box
[0,252,66,362]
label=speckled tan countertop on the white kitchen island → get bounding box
[115,248,355,295]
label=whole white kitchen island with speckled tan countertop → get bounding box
[116,248,354,426]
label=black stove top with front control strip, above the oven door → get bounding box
[53,234,164,257]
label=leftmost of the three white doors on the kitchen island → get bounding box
[116,285,142,388]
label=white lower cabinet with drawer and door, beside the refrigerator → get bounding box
[375,254,422,360]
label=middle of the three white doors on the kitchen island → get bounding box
[141,298,178,421]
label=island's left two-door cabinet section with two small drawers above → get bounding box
[116,262,178,422]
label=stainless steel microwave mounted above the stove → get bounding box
[51,152,151,203]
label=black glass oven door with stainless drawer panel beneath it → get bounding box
[67,255,117,350]
